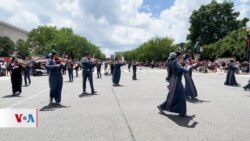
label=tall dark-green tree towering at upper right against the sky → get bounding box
[187,0,248,50]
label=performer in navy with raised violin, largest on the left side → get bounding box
[46,51,65,104]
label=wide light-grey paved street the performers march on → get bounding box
[0,67,250,141]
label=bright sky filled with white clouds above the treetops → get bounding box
[0,0,250,54]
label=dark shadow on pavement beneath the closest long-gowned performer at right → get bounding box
[162,113,198,128]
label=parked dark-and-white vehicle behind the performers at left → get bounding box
[31,60,48,76]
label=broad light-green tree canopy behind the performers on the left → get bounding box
[27,26,105,59]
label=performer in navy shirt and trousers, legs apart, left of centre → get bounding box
[81,53,97,95]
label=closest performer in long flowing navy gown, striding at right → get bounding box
[158,52,188,116]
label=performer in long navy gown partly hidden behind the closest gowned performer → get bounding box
[183,55,198,100]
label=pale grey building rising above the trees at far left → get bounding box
[0,21,28,43]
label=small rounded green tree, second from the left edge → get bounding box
[16,39,30,59]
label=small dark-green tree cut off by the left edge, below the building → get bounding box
[0,36,15,56]
